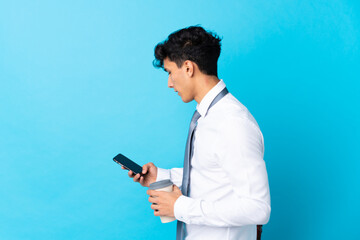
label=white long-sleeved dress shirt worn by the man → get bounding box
[157,80,270,240]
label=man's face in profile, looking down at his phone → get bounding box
[164,58,194,103]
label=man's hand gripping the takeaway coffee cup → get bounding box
[146,185,182,217]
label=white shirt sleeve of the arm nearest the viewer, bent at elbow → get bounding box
[174,118,271,227]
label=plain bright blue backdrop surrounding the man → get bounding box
[0,0,360,240]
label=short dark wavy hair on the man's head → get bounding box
[153,26,221,76]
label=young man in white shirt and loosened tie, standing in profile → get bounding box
[121,26,270,240]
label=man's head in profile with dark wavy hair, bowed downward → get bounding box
[153,26,221,102]
